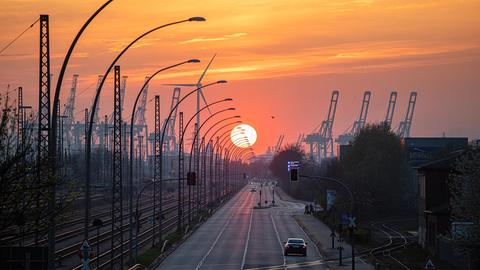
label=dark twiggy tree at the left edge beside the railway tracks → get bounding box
[0,96,76,245]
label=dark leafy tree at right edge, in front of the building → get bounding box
[449,149,480,260]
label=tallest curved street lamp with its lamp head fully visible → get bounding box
[84,17,205,243]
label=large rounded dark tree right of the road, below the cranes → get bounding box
[342,123,413,217]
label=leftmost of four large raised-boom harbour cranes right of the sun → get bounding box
[305,90,339,162]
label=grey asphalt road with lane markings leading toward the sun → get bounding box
[157,182,328,269]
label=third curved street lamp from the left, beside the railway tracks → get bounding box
[128,59,200,265]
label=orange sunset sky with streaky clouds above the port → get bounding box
[0,0,480,153]
